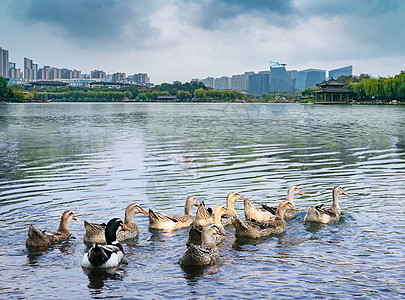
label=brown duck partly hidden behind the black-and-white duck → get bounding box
[83,204,148,244]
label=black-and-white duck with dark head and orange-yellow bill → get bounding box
[81,218,131,269]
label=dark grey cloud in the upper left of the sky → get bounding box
[9,0,157,42]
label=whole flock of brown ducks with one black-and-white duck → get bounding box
[26,185,348,269]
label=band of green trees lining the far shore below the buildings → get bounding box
[0,70,405,104]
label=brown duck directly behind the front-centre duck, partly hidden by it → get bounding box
[186,201,227,246]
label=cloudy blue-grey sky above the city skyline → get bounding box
[0,0,405,84]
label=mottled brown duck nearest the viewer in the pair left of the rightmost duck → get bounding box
[232,200,295,239]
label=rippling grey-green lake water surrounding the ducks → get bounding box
[0,103,405,299]
